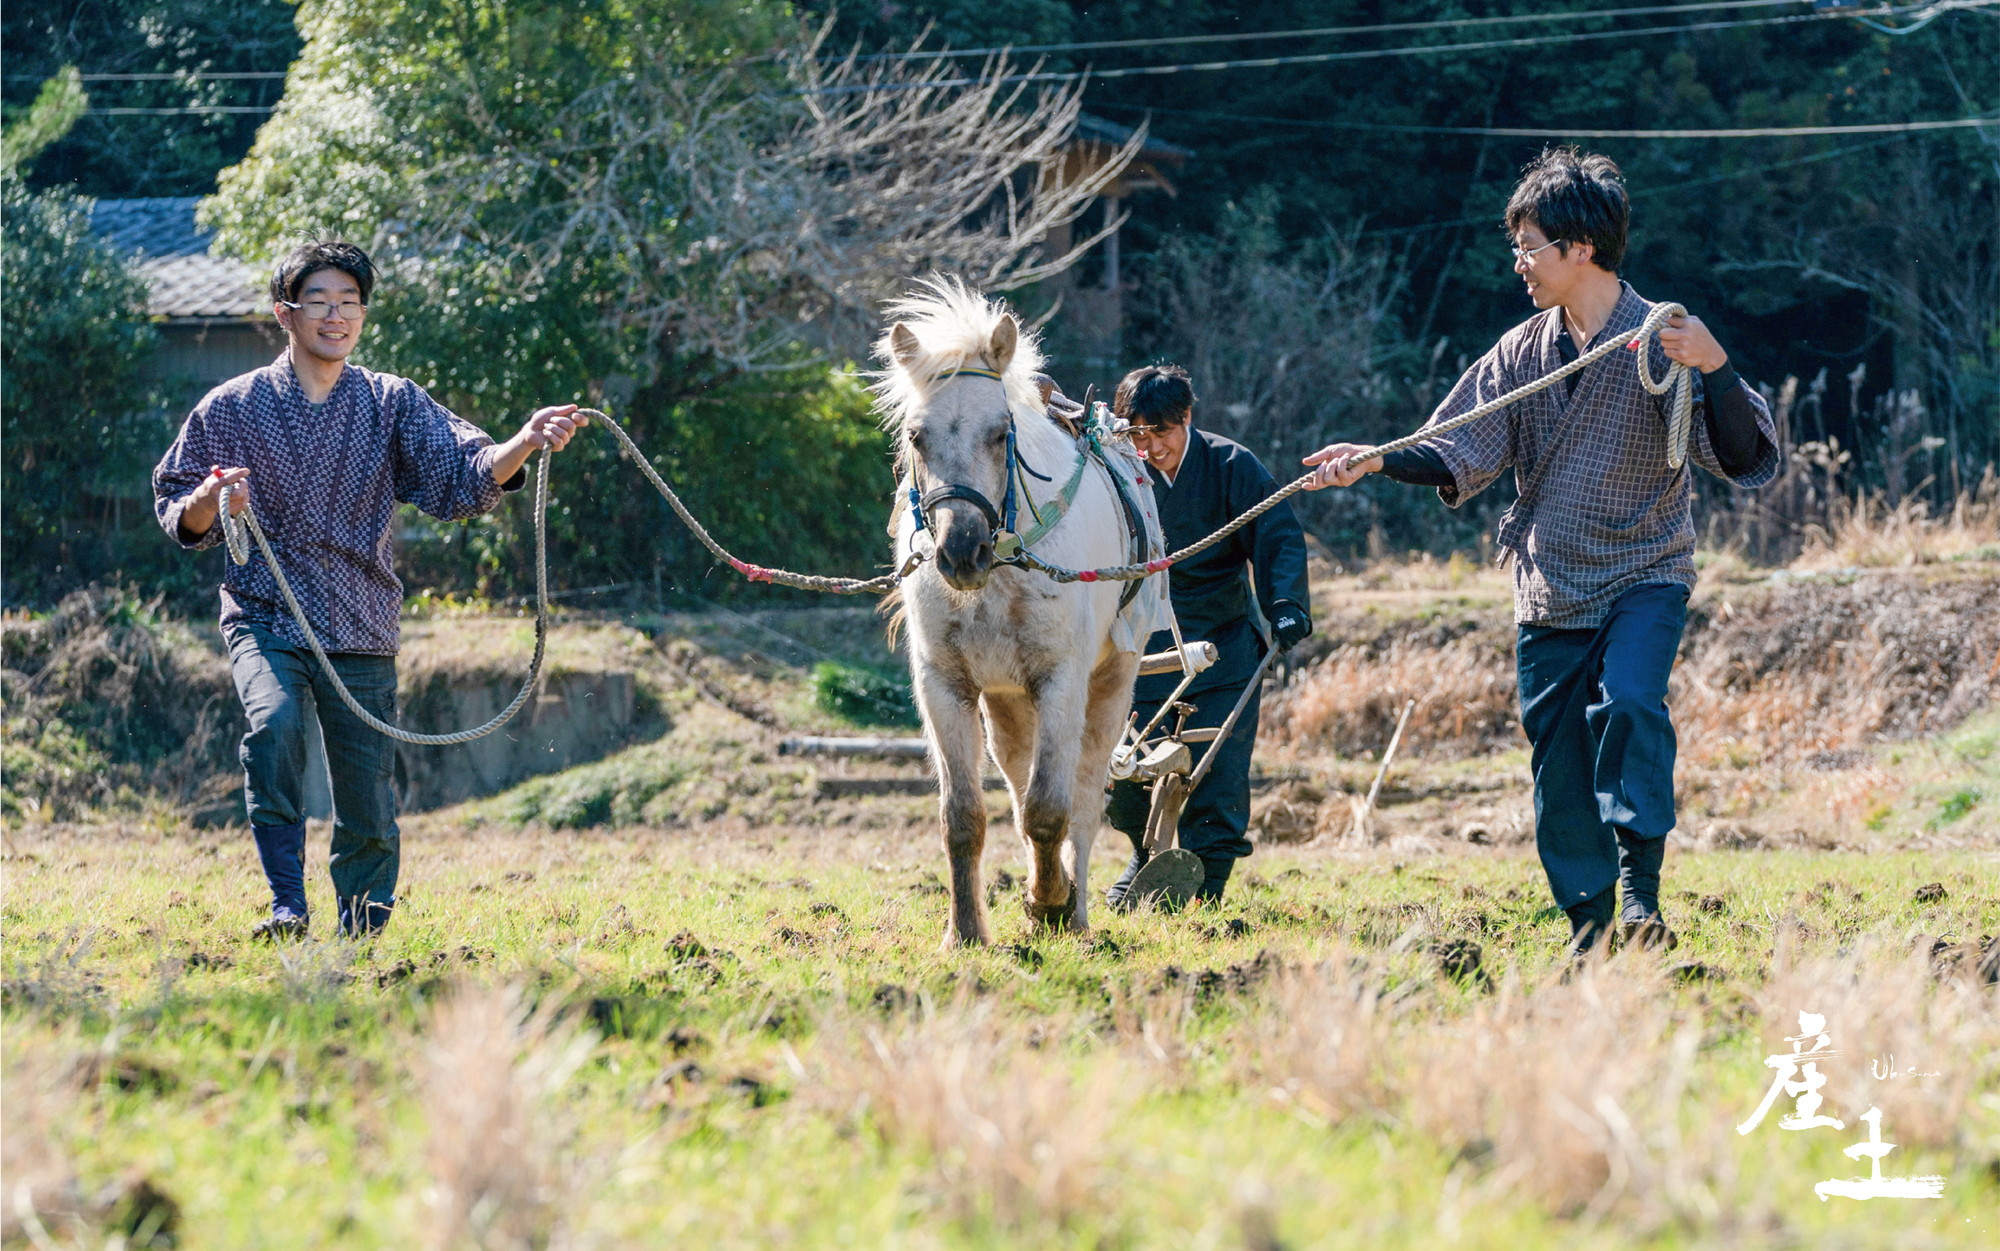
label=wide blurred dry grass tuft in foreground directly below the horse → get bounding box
[818,1005,1140,1231]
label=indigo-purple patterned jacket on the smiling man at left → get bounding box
[152,354,526,655]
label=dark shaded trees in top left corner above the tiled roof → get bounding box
[0,0,298,196]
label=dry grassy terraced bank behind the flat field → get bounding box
[4,554,2000,849]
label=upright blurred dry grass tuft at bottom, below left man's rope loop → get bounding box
[418,985,596,1251]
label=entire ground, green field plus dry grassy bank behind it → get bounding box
[0,547,2000,1251]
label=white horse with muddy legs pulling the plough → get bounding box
[874,278,1164,947]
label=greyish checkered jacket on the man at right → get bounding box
[1422,284,1778,629]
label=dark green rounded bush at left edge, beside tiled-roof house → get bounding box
[0,72,162,602]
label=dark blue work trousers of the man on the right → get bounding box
[1518,584,1688,921]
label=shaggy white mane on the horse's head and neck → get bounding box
[868,274,1046,434]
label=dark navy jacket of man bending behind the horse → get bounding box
[1134,428,1312,703]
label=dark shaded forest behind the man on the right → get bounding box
[832,0,2000,544]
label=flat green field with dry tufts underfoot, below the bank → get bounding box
[4,817,2000,1249]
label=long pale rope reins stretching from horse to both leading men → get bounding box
[216,304,1694,735]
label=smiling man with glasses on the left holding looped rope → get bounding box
[152,242,584,939]
